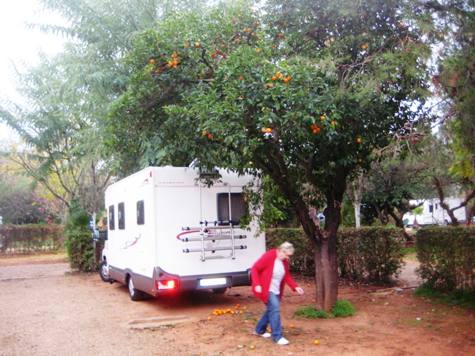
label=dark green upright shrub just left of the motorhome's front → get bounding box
[65,202,97,272]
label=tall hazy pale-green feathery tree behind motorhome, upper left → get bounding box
[0,0,184,213]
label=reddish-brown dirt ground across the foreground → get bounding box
[0,259,475,355]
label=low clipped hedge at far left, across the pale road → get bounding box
[0,224,64,255]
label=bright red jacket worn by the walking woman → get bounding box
[251,249,297,303]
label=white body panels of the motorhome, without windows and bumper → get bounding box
[103,167,265,292]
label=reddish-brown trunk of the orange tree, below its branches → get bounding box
[315,235,338,311]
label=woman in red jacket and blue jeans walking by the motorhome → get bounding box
[251,242,304,345]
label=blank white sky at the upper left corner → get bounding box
[0,0,65,144]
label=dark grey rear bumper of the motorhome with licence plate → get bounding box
[155,267,251,294]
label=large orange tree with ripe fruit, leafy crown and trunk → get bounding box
[109,0,428,310]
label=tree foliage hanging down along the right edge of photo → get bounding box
[425,0,475,224]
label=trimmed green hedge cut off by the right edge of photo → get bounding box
[416,227,475,292]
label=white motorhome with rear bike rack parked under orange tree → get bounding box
[100,166,265,300]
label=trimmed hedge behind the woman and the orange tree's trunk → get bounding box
[266,227,404,283]
